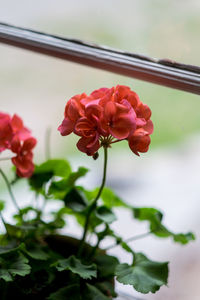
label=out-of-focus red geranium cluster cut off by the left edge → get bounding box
[0,112,37,177]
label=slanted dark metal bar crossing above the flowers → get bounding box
[0,23,200,95]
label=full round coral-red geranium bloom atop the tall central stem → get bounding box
[58,85,153,155]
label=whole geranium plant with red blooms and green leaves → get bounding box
[0,85,194,300]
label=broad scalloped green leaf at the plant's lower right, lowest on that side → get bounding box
[116,253,168,294]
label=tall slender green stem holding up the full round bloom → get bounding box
[78,147,108,256]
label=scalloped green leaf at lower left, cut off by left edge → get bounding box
[0,252,31,281]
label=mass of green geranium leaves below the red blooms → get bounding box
[0,159,194,300]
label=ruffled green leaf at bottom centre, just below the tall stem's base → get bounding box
[55,255,97,279]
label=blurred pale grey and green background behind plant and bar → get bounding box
[0,0,200,300]
